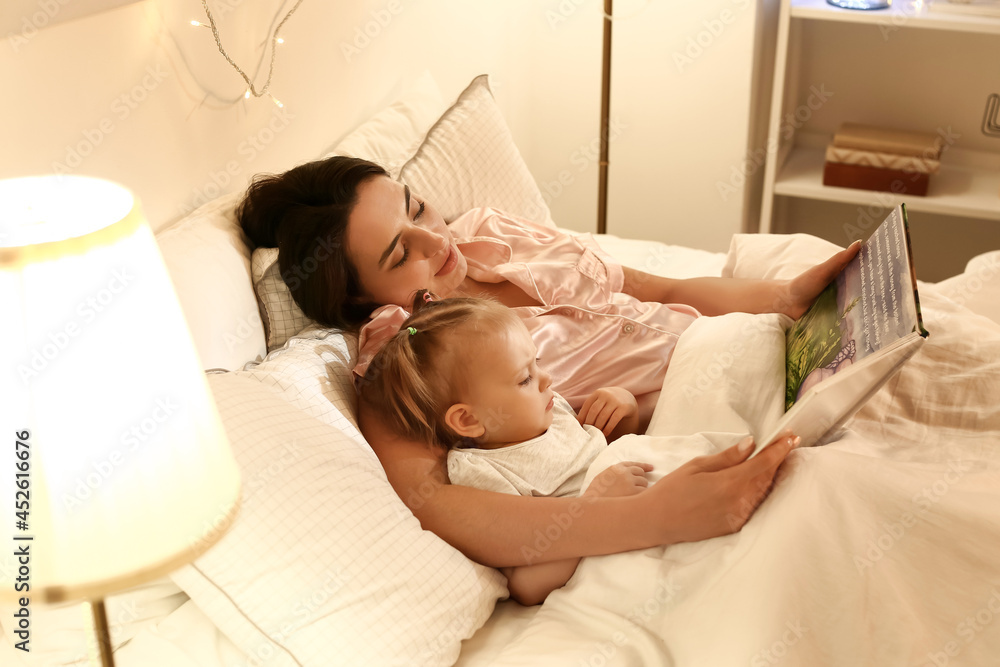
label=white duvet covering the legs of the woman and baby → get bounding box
[495,240,1000,667]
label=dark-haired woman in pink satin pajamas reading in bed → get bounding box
[239,157,858,567]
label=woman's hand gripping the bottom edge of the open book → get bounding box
[641,436,796,544]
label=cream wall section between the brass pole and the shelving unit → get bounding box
[608,0,778,252]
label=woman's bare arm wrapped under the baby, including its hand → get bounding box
[359,402,790,567]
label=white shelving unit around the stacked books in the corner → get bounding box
[760,0,1000,240]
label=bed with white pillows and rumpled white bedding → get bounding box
[0,77,1000,667]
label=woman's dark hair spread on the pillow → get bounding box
[236,156,388,329]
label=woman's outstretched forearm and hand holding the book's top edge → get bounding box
[622,242,861,319]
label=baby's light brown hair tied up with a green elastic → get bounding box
[359,290,518,447]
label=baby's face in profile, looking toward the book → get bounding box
[462,321,555,447]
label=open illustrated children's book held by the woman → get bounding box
[754,204,927,451]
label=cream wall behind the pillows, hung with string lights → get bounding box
[0,0,601,231]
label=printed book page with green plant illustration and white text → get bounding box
[785,206,922,410]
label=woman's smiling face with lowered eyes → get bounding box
[345,176,468,307]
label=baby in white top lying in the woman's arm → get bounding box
[359,290,652,605]
